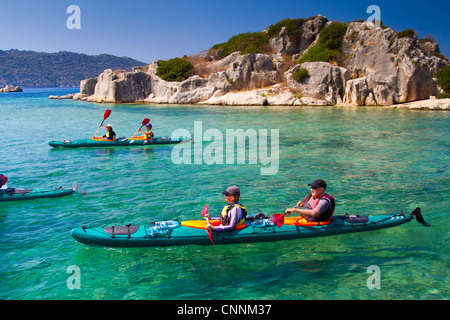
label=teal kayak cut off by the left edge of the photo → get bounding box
[0,182,86,202]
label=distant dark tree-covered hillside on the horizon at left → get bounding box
[0,49,146,88]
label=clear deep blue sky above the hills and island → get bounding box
[0,0,450,63]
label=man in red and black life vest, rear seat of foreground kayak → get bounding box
[285,179,335,222]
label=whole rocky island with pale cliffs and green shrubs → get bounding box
[57,15,450,109]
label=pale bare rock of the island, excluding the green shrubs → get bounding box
[74,15,448,106]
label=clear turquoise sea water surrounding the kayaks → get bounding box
[0,89,450,300]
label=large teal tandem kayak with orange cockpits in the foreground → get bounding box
[71,208,428,247]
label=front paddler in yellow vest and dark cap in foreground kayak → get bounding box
[205,186,247,232]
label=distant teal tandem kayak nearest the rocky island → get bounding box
[48,137,191,148]
